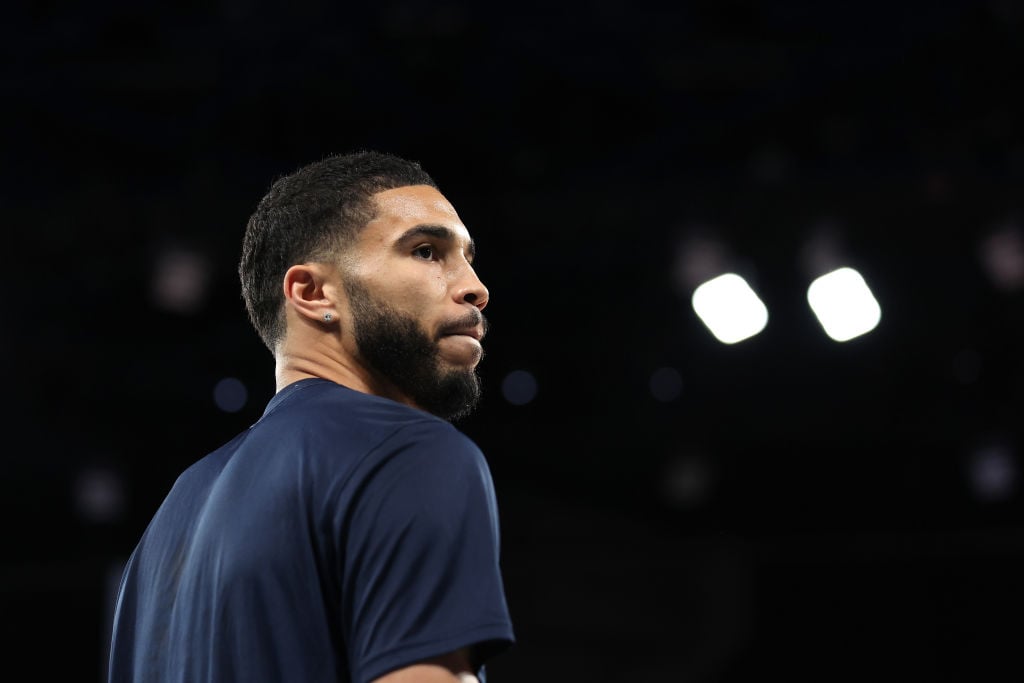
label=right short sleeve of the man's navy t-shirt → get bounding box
[338,422,513,683]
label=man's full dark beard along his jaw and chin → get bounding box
[344,278,481,422]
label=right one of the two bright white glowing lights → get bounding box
[807,267,882,342]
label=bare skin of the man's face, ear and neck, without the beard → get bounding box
[274,185,488,409]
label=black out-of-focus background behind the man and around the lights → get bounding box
[6,0,1024,683]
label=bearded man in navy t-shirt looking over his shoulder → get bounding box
[110,152,513,683]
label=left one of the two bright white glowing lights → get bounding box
[692,272,768,344]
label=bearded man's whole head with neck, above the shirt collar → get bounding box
[240,153,487,419]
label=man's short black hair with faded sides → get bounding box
[239,151,437,353]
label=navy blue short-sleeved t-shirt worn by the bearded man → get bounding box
[110,379,514,683]
